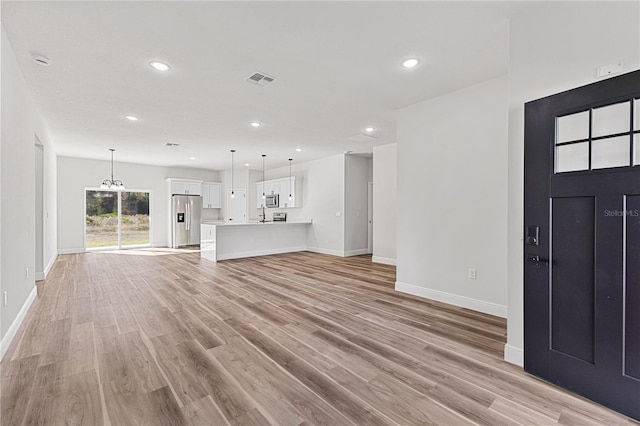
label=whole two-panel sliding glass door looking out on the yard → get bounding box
[85,189,151,249]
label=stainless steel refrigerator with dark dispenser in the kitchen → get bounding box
[171,195,202,248]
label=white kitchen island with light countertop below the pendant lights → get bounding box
[200,219,312,262]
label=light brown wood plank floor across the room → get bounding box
[0,252,638,425]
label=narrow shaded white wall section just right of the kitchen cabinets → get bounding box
[344,155,371,256]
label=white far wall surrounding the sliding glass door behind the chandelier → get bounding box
[58,156,219,253]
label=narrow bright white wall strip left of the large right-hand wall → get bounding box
[373,143,398,265]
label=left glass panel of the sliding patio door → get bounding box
[85,191,118,248]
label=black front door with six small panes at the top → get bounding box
[524,71,640,419]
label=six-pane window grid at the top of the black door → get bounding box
[555,99,640,173]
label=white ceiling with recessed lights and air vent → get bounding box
[2,1,531,170]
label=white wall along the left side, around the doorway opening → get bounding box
[0,27,57,355]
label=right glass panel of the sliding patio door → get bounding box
[120,192,150,246]
